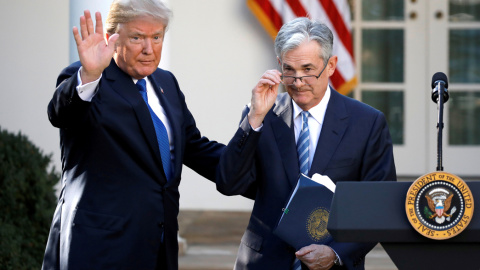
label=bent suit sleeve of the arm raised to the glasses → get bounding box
[216,107,261,199]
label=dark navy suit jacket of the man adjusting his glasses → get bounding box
[217,89,396,270]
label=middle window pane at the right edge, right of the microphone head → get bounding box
[449,30,480,83]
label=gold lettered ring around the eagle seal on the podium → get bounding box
[405,171,474,240]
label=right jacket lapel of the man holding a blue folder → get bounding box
[309,88,348,176]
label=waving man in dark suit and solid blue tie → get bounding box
[43,0,224,270]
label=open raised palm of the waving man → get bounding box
[73,10,118,84]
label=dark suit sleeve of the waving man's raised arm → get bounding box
[47,62,90,128]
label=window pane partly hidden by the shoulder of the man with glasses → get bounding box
[362,90,404,144]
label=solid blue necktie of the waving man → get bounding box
[137,79,171,181]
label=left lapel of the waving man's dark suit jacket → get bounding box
[105,60,166,174]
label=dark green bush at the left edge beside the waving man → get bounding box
[0,127,59,269]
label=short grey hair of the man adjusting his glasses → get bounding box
[275,17,333,64]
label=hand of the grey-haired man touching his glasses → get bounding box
[248,69,282,128]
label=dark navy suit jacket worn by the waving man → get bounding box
[43,60,224,270]
